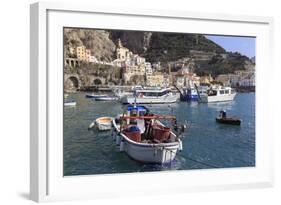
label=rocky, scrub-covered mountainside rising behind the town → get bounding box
[64,28,254,76]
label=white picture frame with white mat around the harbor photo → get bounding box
[30,2,273,202]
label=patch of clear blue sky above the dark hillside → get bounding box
[205,35,256,58]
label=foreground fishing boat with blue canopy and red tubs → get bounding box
[112,105,184,164]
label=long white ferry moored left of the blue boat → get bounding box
[121,88,178,104]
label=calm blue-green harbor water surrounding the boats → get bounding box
[63,93,255,176]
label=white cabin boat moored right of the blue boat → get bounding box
[199,86,236,103]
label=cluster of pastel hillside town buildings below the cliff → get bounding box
[65,39,255,88]
